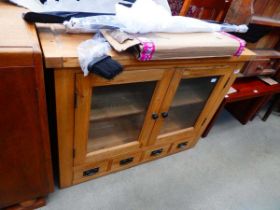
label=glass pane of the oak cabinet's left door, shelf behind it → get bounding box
[87,81,157,153]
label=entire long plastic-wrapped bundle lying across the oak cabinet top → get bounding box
[64,0,248,34]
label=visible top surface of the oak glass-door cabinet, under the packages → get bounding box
[36,24,255,68]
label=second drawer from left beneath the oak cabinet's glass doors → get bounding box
[111,152,141,171]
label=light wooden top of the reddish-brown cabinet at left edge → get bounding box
[0,1,41,67]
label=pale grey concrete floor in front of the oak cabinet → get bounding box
[41,112,280,210]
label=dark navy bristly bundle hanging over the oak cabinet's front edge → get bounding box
[88,55,123,79]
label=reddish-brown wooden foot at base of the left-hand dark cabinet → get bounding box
[5,198,46,210]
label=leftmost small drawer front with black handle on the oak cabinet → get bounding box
[74,161,109,182]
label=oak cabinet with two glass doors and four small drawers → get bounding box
[37,24,254,187]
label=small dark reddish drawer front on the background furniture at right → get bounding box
[243,60,273,76]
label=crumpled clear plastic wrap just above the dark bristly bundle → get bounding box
[77,33,111,76]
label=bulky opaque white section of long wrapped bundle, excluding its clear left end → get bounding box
[116,0,248,33]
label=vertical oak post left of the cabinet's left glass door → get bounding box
[54,69,75,188]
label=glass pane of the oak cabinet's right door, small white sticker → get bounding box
[160,77,219,134]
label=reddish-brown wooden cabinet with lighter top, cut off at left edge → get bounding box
[0,2,53,209]
